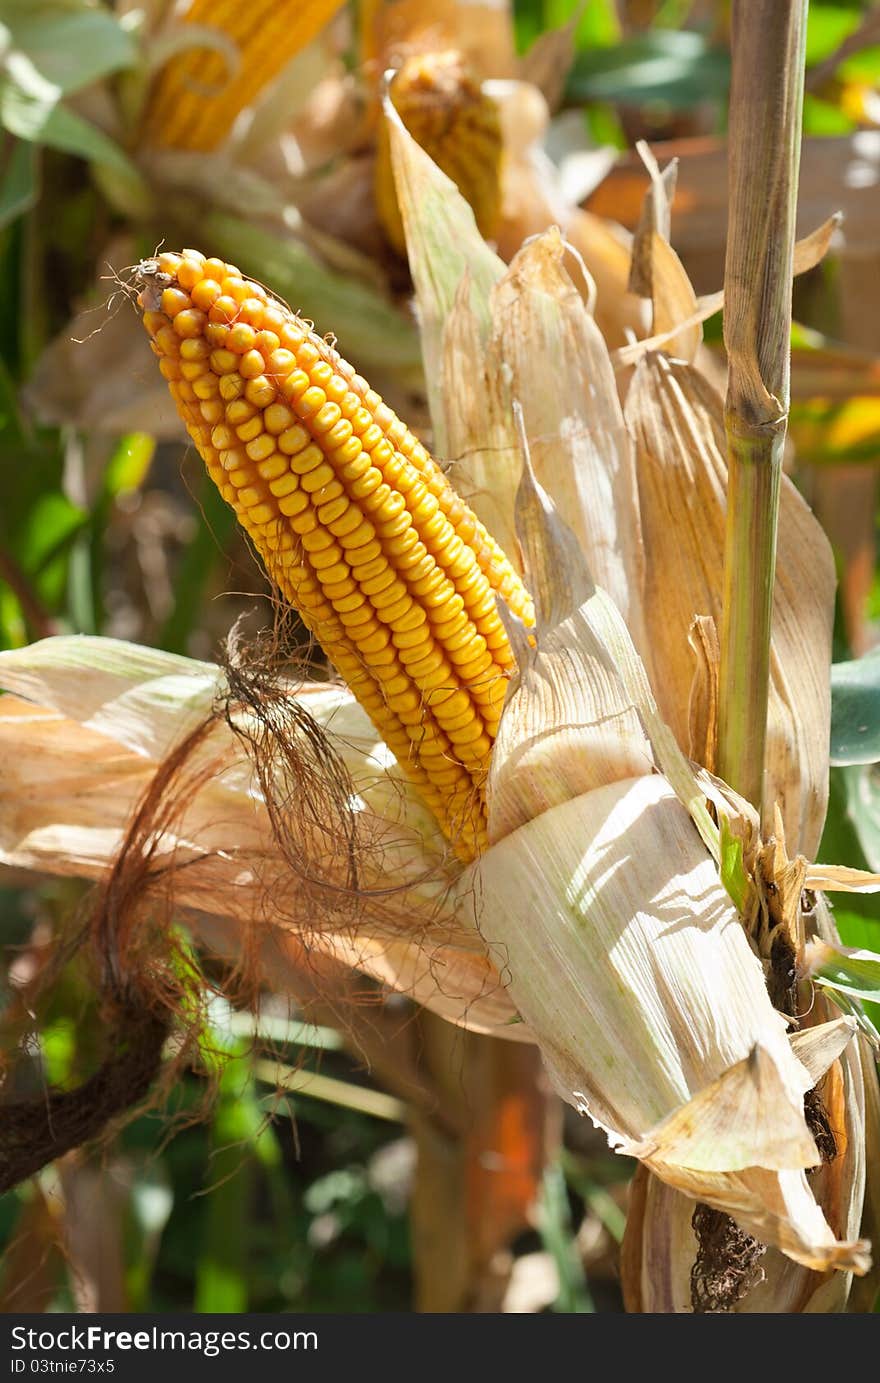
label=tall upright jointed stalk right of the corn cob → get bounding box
[718,0,808,826]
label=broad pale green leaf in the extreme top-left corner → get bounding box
[3,0,138,95]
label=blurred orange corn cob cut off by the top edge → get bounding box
[143,0,342,151]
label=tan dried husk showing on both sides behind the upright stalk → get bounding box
[625,354,834,856]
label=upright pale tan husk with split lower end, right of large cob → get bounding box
[443,228,646,647]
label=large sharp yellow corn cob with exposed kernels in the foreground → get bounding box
[138,250,534,859]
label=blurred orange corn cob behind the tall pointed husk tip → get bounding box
[375,53,502,254]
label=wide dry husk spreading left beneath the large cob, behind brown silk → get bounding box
[0,638,529,1040]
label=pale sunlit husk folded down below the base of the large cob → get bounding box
[459,774,868,1271]
